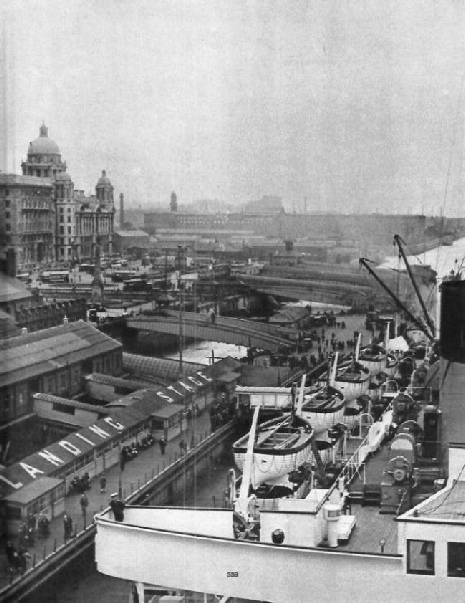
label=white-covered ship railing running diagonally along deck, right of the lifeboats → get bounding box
[316,405,392,513]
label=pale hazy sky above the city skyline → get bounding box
[4,0,465,215]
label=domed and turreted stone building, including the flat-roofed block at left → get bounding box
[0,124,115,269]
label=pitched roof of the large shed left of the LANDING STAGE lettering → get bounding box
[0,321,121,387]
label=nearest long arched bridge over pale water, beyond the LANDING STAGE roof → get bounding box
[127,310,292,352]
